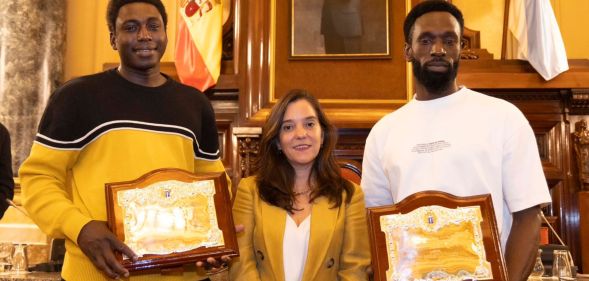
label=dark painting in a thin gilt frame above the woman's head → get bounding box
[289,0,391,59]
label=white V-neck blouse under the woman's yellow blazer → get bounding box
[282,214,311,281]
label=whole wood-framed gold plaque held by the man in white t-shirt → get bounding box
[368,191,507,281]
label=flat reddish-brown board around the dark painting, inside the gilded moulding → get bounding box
[270,0,407,100]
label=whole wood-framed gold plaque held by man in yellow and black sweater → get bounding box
[106,169,239,271]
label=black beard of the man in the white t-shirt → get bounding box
[411,60,458,94]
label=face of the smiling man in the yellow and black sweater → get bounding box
[110,2,168,71]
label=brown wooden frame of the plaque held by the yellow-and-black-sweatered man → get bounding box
[105,168,239,271]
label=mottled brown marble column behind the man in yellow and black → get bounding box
[0,0,66,173]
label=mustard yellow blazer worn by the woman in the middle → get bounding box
[230,177,370,281]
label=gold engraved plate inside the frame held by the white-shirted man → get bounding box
[380,203,493,281]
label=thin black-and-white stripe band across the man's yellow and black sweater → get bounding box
[35,120,219,160]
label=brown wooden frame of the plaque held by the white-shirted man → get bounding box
[367,191,507,281]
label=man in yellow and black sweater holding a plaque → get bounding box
[19,0,224,281]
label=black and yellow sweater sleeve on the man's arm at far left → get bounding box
[19,88,91,243]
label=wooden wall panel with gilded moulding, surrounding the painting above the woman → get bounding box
[237,0,411,128]
